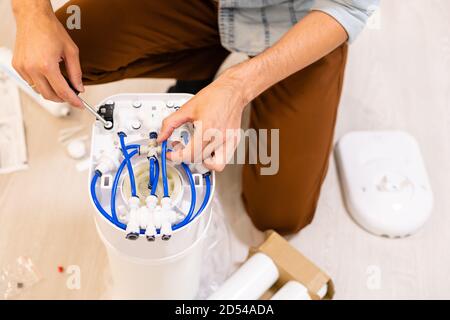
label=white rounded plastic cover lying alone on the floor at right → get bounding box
[336,131,433,238]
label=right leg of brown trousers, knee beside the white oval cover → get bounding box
[242,44,347,234]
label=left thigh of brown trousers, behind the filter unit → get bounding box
[56,0,229,84]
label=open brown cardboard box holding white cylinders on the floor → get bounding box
[249,231,334,300]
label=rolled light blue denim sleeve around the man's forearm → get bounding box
[311,0,380,42]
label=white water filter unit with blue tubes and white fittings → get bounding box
[90,94,215,299]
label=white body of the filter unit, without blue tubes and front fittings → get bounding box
[90,94,215,299]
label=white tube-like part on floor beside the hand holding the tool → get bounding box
[0,47,70,117]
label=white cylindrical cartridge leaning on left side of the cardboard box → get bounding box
[209,253,279,300]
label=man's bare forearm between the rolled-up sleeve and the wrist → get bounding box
[228,11,348,102]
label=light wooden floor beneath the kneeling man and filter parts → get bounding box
[0,0,450,299]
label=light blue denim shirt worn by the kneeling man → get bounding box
[219,0,380,56]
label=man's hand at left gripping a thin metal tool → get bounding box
[12,0,84,107]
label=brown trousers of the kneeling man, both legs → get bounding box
[57,0,347,234]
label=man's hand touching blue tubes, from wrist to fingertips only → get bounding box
[158,70,248,171]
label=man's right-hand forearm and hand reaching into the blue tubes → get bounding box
[159,11,348,171]
